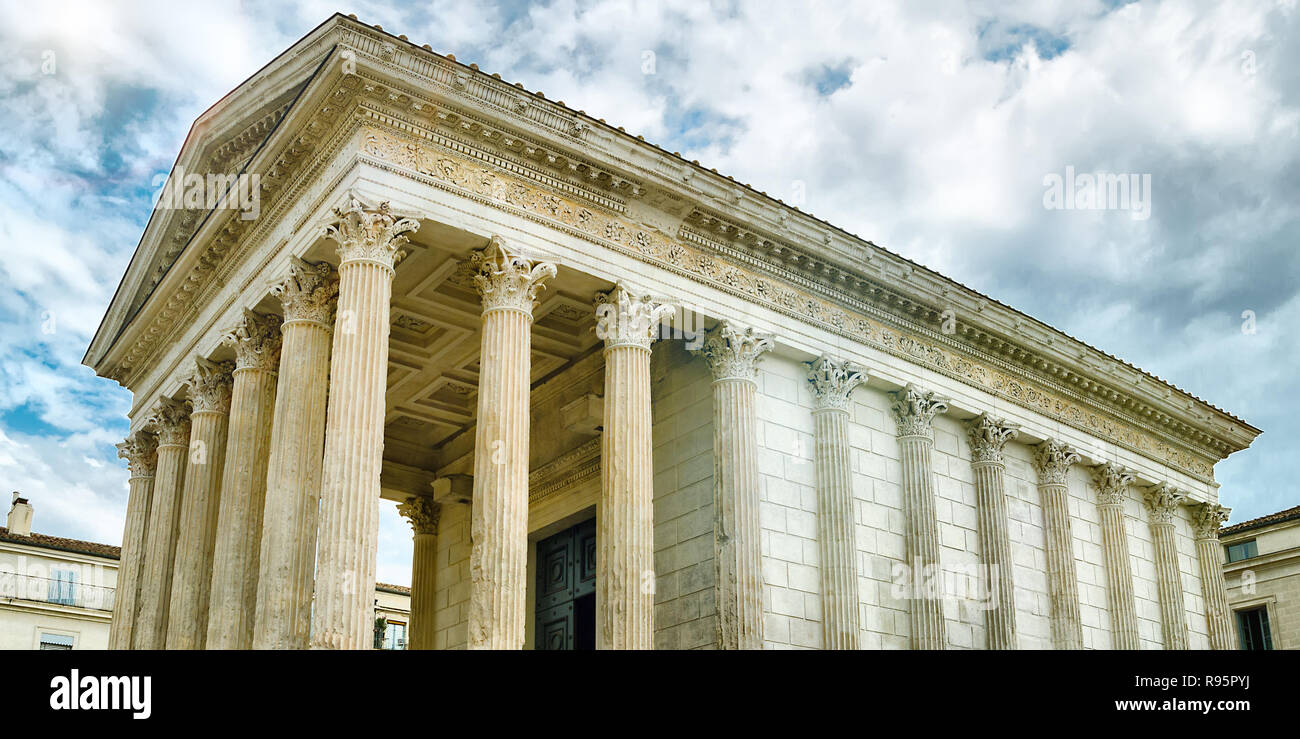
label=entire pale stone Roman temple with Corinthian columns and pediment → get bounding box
[85,10,1258,649]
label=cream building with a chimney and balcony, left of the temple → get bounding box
[0,493,121,649]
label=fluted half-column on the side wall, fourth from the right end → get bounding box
[1034,438,1083,649]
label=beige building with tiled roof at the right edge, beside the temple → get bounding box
[1219,506,1300,649]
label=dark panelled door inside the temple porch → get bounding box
[533,519,595,649]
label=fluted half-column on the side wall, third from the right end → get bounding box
[1092,462,1141,649]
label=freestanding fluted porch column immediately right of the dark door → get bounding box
[595,285,672,649]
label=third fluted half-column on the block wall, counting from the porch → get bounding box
[892,385,948,649]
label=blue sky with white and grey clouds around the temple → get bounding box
[0,0,1300,583]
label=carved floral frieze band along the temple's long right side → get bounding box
[348,128,1214,480]
